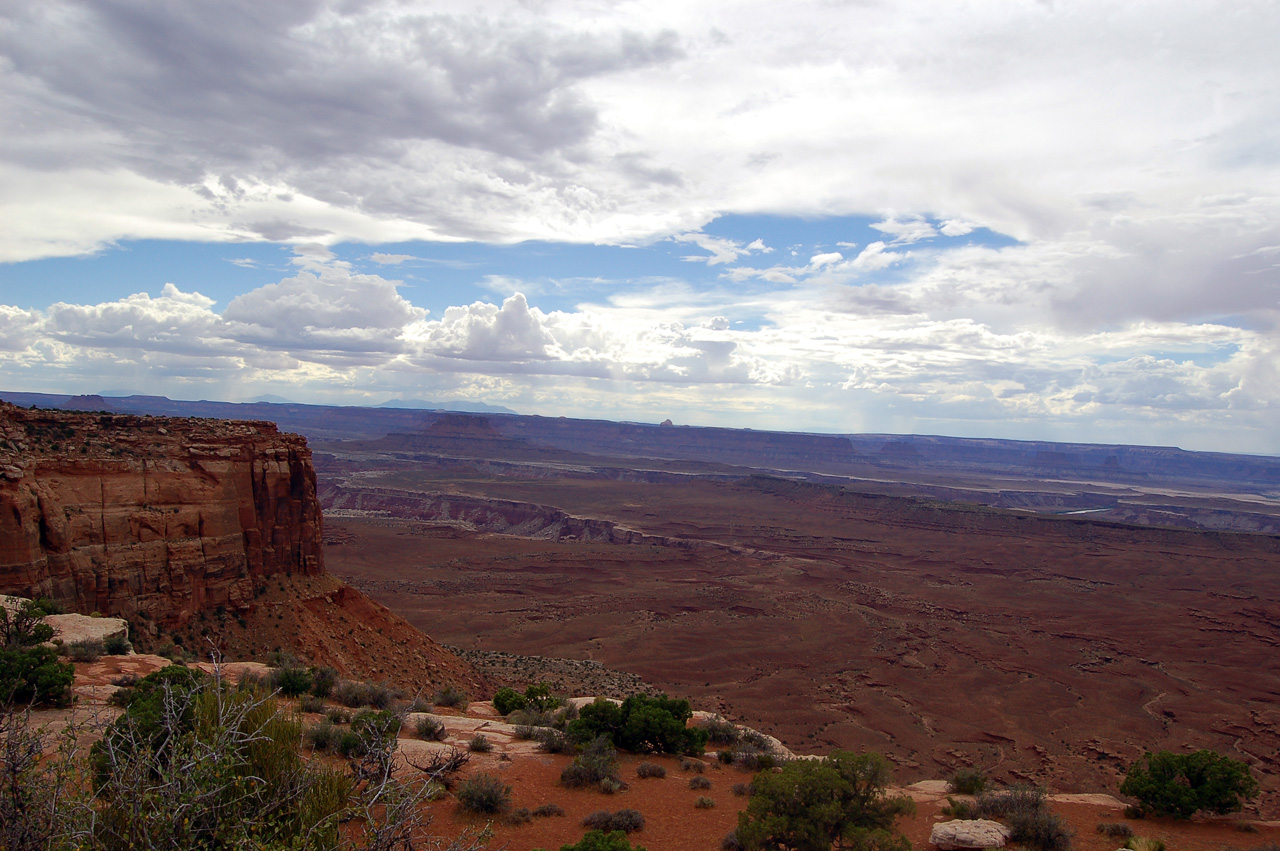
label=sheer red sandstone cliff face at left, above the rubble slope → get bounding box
[0,403,324,628]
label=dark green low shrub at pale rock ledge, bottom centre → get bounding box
[566,695,707,756]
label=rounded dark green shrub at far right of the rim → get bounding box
[1120,750,1258,819]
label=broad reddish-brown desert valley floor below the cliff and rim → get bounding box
[325,472,1280,818]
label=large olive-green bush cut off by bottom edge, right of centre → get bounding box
[737,751,915,851]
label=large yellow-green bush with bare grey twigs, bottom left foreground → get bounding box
[91,667,356,851]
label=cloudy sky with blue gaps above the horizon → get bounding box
[0,0,1280,454]
